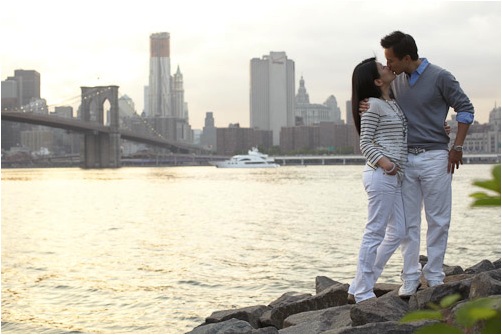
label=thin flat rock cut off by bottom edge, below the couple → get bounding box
[323,321,436,334]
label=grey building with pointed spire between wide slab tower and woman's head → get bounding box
[295,76,342,126]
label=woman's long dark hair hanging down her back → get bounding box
[352,57,382,134]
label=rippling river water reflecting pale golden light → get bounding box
[1,165,500,333]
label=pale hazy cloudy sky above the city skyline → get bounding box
[0,0,501,129]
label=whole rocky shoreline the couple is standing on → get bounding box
[187,256,500,334]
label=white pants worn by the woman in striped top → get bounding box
[349,166,405,302]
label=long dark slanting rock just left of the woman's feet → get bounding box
[260,284,349,329]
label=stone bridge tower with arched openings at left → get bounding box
[80,86,121,169]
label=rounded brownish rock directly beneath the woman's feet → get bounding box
[350,292,408,327]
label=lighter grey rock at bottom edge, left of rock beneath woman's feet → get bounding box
[279,305,352,334]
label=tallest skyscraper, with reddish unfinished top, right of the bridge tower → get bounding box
[145,33,172,117]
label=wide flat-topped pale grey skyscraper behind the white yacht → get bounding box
[250,52,295,145]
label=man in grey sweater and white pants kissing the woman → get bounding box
[380,31,474,297]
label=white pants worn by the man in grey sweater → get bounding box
[401,150,452,281]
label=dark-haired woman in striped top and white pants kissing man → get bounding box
[349,58,407,303]
